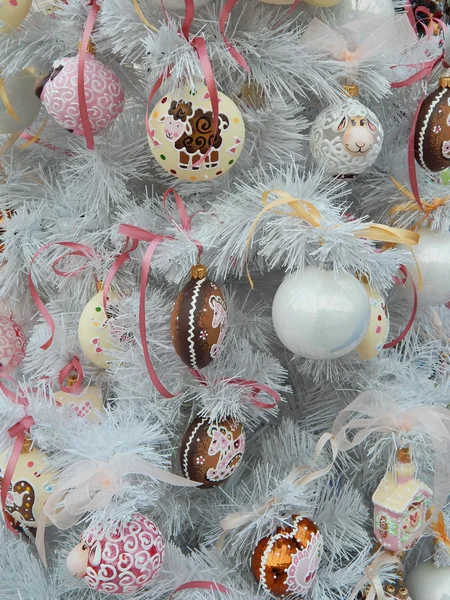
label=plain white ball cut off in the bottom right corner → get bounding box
[406,560,450,600]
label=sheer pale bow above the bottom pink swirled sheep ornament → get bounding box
[36,454,201,566]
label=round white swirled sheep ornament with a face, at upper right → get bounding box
[309,98,383,177]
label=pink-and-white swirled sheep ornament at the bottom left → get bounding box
[66,513,164,594]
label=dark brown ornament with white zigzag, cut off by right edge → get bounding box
[414,77,450,172]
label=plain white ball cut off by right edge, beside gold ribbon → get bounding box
[397,227,450,306]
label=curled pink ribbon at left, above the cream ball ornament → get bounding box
[28,242,99,350]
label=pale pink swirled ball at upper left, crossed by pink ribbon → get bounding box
[36,52,125,135]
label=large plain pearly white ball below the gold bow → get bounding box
[272,266,370,360]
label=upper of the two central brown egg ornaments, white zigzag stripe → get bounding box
[171,265,228,369]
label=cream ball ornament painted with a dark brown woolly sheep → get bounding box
[148,85,245,181]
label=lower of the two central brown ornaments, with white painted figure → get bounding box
[180,417,245,488]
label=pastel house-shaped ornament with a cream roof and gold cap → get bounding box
[372,448,433,552]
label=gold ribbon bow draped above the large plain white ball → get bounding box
[245,190,422,289]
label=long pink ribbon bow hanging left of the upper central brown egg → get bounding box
[103,188,203,398]
